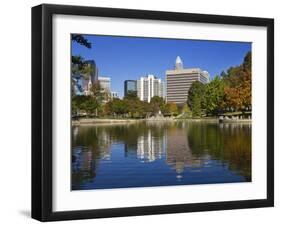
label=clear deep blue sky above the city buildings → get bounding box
[72,35,251,97]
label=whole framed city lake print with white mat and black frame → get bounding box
[32,4,274,221]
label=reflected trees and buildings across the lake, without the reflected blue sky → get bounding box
[72,122,251,189]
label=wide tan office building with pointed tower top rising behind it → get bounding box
[166,56,210,105]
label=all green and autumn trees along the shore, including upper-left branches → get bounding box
[72,35,252,118]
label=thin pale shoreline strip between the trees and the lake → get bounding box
[71,118,252,126]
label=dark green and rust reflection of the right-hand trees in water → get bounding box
[188,123,251,181]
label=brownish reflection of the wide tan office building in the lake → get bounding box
[166,129,206,173]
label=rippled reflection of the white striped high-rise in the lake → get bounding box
[137,129,166,162]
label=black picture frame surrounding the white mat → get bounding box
[32,4,274,221]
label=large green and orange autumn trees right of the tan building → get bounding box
[187,52,252,117]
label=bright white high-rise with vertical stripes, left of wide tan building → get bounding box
[137,75,165,103]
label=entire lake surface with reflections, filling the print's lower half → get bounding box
[72,121,251,190]
